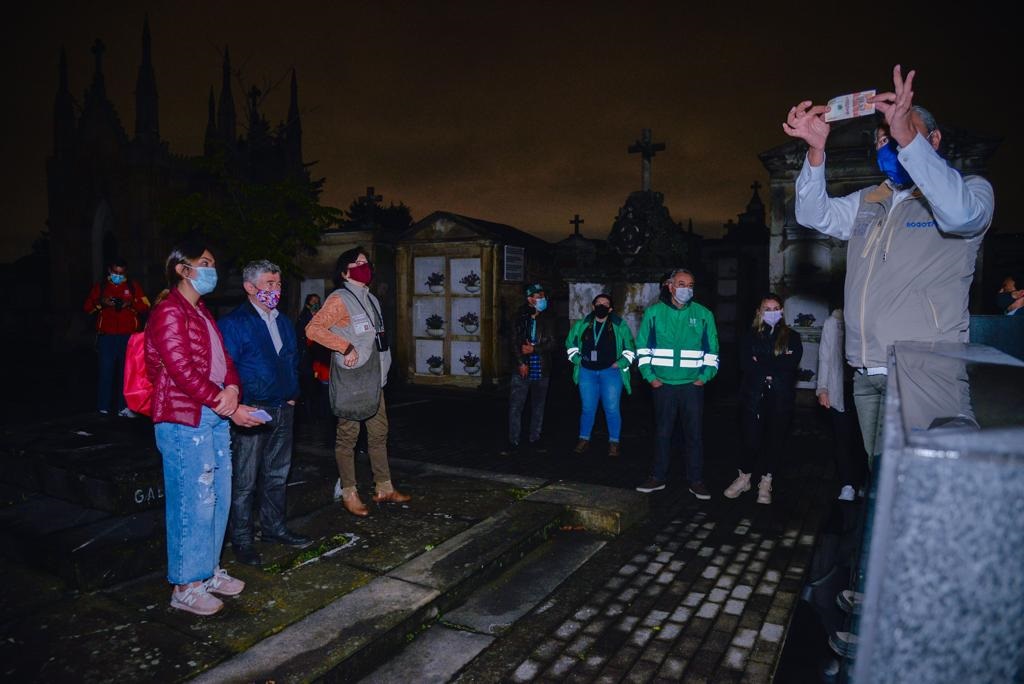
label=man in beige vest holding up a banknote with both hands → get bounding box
[782,65,995,466]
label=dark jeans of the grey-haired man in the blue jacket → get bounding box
[231,403,295,546]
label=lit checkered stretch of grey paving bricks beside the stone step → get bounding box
[512,509,814,682]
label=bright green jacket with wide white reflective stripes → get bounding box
[637,301,718,385]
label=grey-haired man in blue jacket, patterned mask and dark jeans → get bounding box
[218,260,310,565]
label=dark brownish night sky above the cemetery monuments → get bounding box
[0,0,1022,261]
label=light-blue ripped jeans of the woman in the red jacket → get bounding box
[154,407,231,585]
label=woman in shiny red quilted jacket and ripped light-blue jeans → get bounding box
[145,240,262,615]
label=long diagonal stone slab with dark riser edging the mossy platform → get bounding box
[187,501,564,682]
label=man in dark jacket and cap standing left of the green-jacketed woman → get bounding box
[502,283,556,456]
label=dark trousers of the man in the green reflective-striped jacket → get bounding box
[650,383,703,484]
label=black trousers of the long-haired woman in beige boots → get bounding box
[737,385,795,475]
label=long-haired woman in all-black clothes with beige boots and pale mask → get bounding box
[725,294,804,504]
